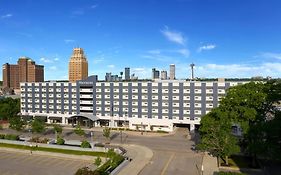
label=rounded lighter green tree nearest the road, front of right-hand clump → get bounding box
[197,109,240,165]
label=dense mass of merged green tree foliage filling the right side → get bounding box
[198,81,281,166]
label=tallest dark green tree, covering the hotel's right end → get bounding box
[218,82,270,166]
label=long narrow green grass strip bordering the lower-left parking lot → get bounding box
[0,143,106,157]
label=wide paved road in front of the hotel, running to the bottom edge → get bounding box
[0,128,202,175]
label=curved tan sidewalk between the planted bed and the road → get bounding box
[114,145,153,175]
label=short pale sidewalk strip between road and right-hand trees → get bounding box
[201,154,219,175]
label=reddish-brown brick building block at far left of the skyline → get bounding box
[2,57,44,89]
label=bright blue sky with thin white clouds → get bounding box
[0,0,281,80]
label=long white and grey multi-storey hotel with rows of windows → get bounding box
[20,77,245,131]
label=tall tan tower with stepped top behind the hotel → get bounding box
[68,48,88,82]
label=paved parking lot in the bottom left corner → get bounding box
[0,150,90,175]
